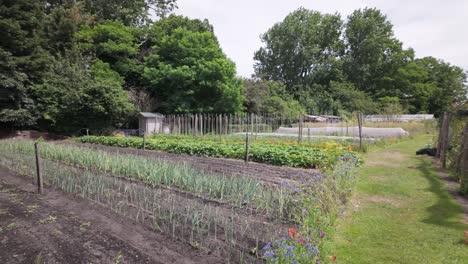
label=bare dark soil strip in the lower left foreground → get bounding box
[0,167,222,263]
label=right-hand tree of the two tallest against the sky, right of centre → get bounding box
[343,8,414,98]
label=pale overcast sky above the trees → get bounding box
[176,0,468,77]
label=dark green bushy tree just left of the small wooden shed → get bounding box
[33,54,134,133]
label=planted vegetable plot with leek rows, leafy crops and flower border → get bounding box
[0,137,359,263]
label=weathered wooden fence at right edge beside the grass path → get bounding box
[436,110,468,194]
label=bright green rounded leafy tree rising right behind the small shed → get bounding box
[143,16,243,113]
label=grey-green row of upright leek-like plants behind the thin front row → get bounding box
[0,141,289,216]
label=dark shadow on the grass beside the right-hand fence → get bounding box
[417,158,466,231]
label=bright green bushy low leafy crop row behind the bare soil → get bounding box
[76,136,355,168]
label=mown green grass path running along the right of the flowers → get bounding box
[334,135,468,264]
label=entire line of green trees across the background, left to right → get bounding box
[0,0,467,133]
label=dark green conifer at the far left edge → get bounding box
[0,0,50,128]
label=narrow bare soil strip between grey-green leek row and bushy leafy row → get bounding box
[61,141,318,184]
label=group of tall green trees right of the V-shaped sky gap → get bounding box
[254,8,467,114]
